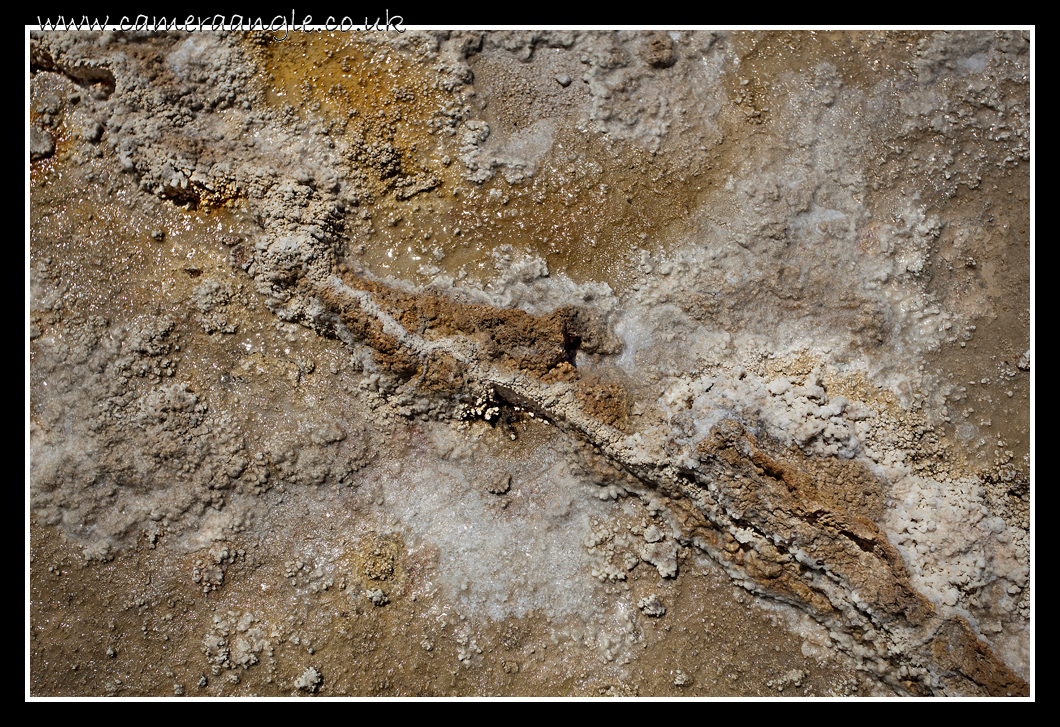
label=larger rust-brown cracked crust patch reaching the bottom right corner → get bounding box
[674,420,1029,696]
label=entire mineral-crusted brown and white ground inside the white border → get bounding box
[29,31,1032,696]
